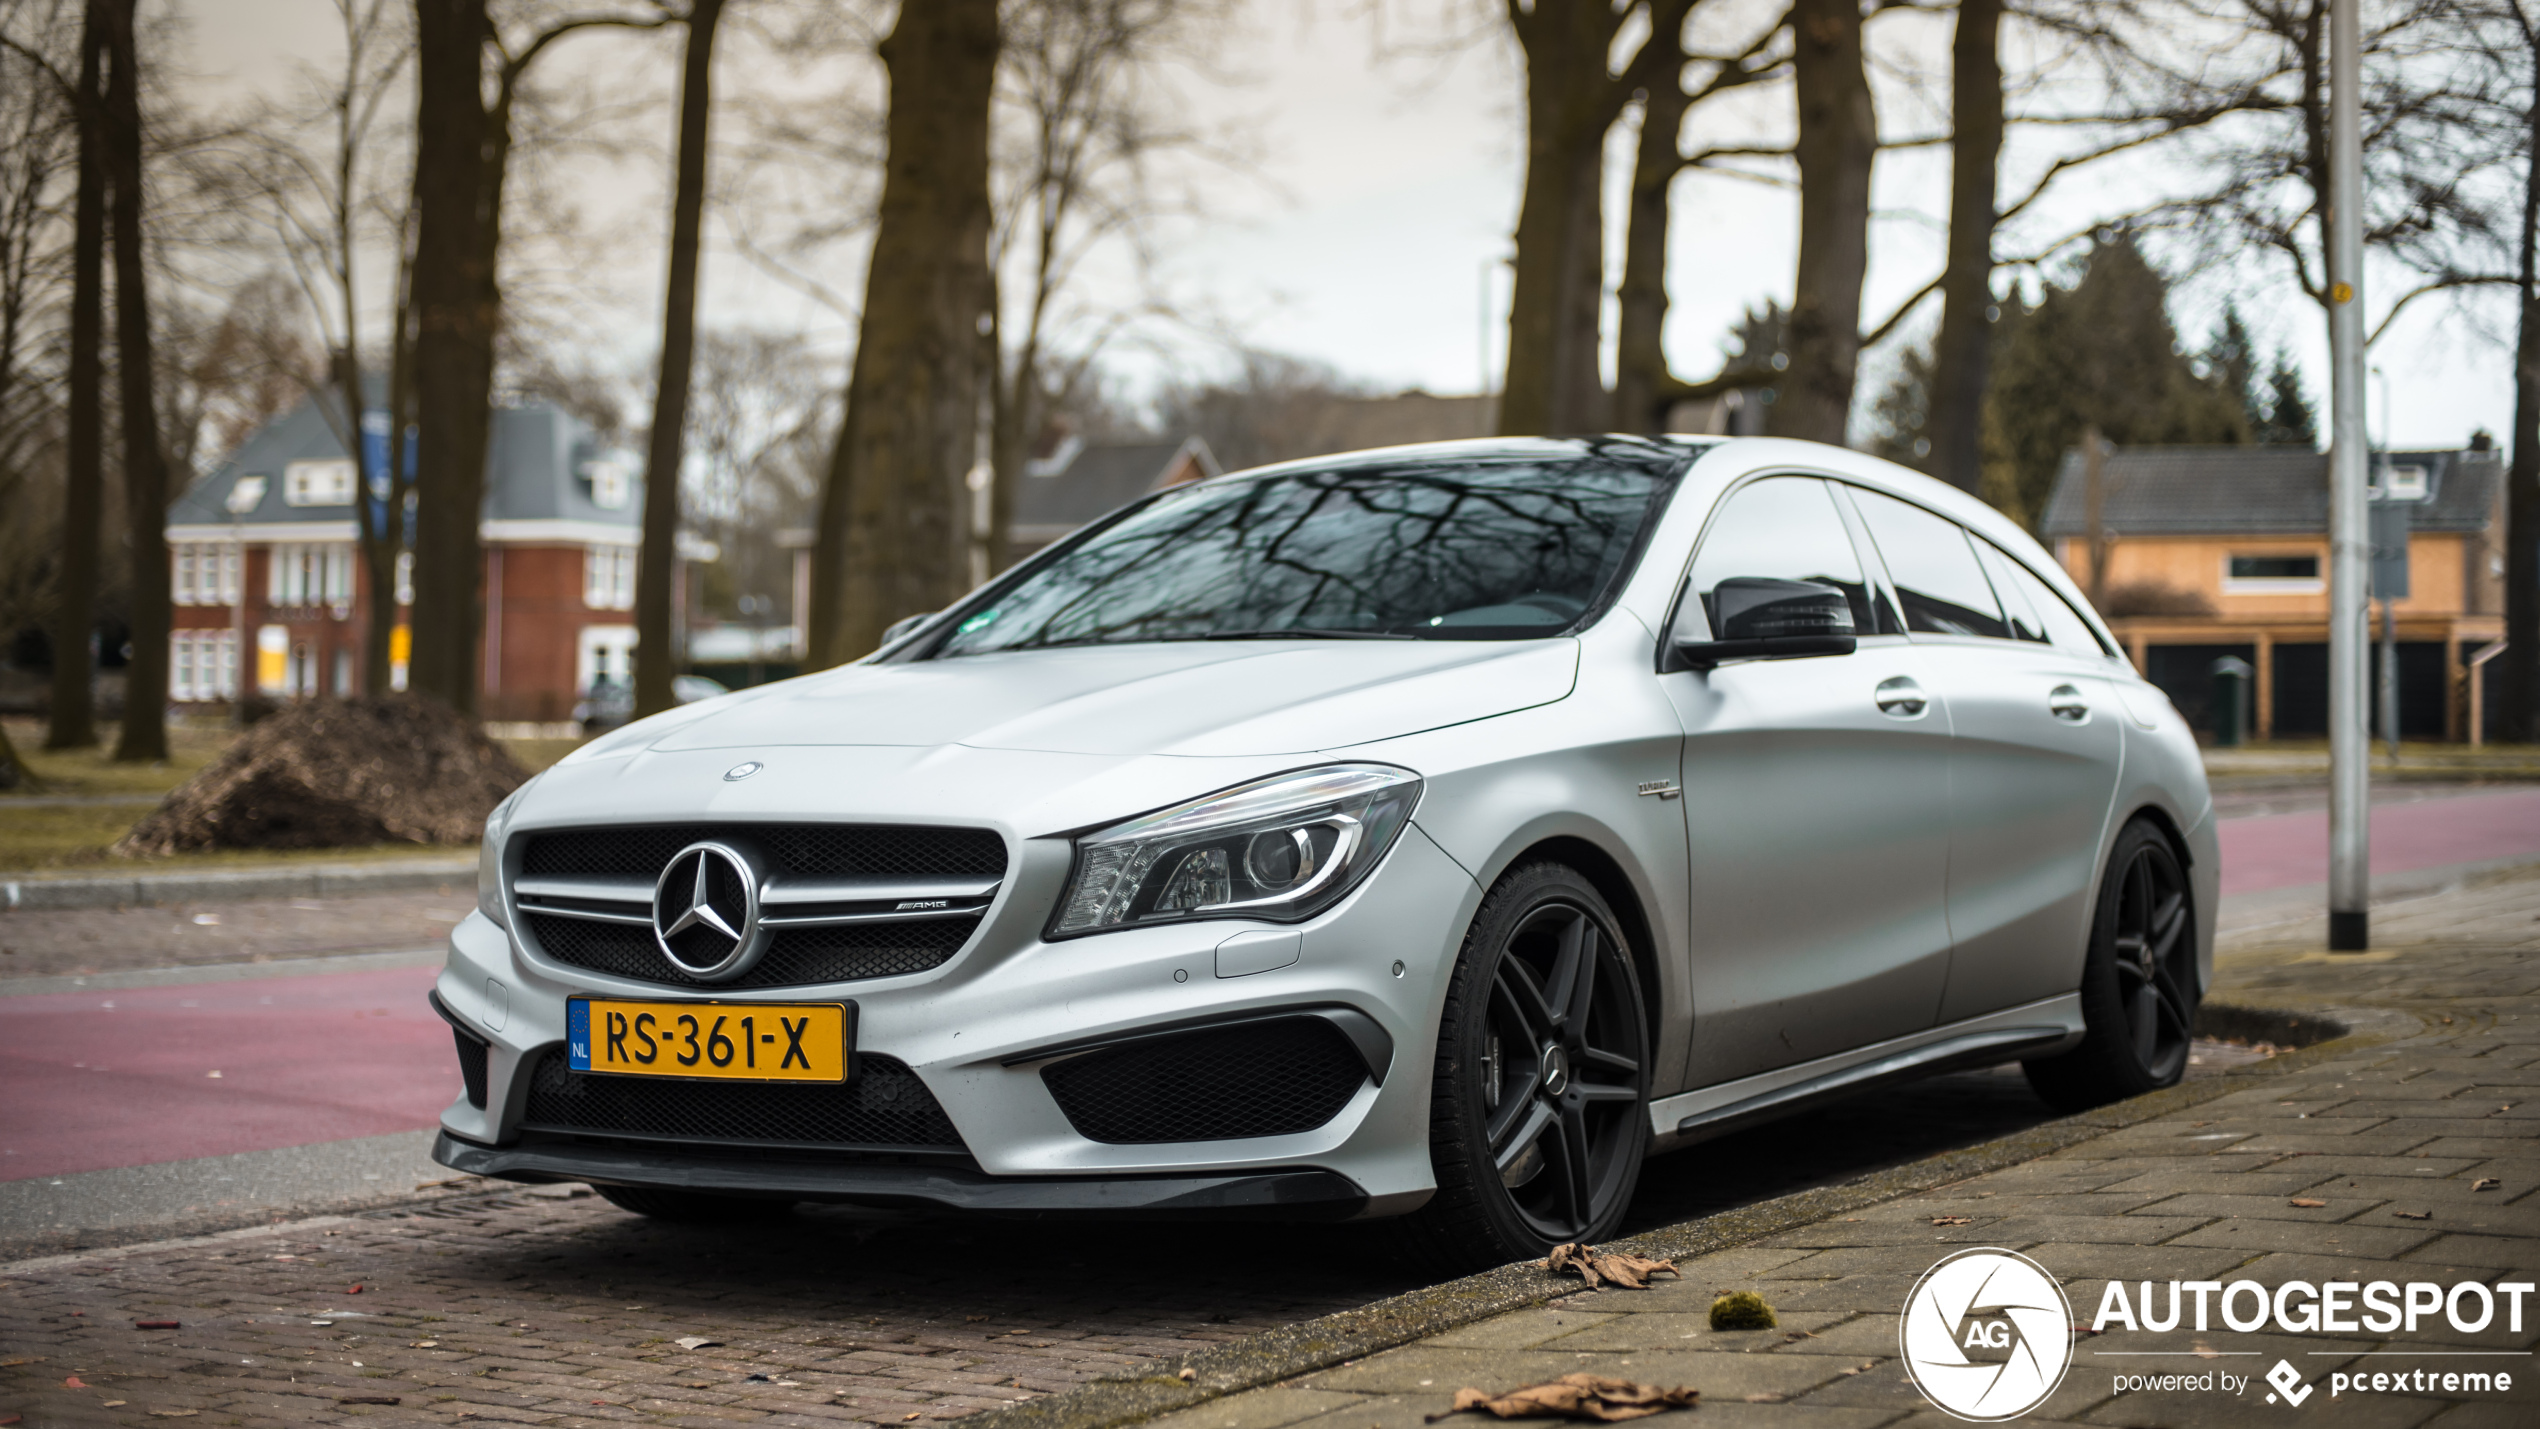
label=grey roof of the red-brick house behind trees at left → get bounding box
[168,393,643,538]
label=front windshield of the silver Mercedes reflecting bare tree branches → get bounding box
[935,452,1681,657]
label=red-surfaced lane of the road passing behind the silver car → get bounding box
[0,789,2540,1180]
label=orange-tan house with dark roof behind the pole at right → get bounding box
[2040,444,2504,741]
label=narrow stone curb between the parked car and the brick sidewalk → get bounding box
[960,1008,2416,1429]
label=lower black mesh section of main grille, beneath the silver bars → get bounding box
[523,914,978,987]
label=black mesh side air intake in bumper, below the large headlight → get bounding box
[1041,1018,1367,1145]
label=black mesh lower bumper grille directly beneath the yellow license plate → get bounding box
[521,1048,970,1155]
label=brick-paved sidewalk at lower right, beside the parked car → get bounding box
[1151,881,2540,1429]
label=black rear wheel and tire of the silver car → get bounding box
[2024,820,2202,1112]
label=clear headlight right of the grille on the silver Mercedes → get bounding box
[1049,764,1420,939]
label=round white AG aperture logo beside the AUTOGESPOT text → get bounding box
[1900,1246,2073,1424]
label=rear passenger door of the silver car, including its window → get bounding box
[1849,487,2123,1023]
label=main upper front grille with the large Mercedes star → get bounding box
[521,825,1006,987]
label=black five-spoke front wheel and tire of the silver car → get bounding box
[1405,863,1651,1274]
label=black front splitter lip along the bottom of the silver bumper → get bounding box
[432,1132,1367,1221]
